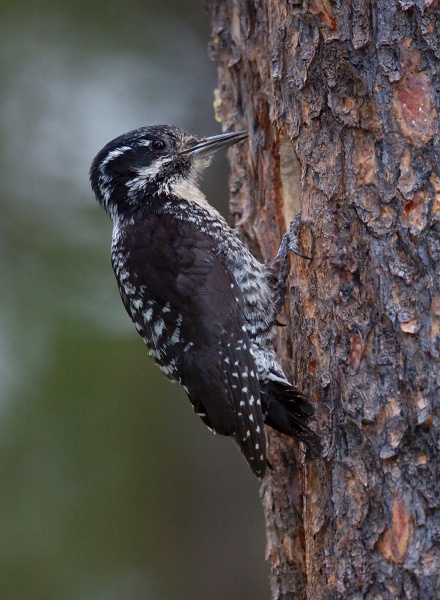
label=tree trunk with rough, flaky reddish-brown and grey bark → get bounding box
[209,0,440,600]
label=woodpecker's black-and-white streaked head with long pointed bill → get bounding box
[90,125,247,219]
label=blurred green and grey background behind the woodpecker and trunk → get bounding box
[0,0,269,600]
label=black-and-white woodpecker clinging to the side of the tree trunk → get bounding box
[90,125,320,478]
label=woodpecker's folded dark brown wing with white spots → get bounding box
[115,215,266,476]
